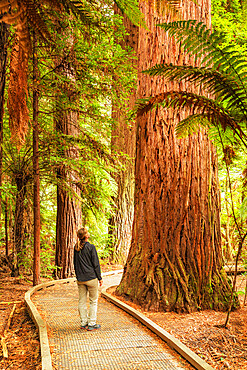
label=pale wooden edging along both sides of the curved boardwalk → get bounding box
[25,270,214,370]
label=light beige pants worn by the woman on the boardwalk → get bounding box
[77,279,99,326]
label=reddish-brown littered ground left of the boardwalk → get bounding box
[0,269,41,370]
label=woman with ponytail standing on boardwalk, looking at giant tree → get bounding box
[74,227,103,330]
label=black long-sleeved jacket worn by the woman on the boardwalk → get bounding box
[74,242,102,281]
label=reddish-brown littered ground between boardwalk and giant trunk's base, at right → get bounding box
[107,275,247,370]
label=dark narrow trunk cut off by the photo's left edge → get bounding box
[0,22,9,231]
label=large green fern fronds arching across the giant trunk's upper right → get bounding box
[136,20,247,147]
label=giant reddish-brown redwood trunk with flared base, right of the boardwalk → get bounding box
[118,0,237,311]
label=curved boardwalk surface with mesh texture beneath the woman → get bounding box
[26,274,212,370]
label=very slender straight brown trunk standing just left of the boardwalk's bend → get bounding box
[33,32,40,285]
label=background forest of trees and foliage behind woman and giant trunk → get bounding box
[0,0,247,306]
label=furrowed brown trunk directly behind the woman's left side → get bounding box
[55,42,82,278]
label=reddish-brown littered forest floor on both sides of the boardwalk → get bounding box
[0,254,247,370]
